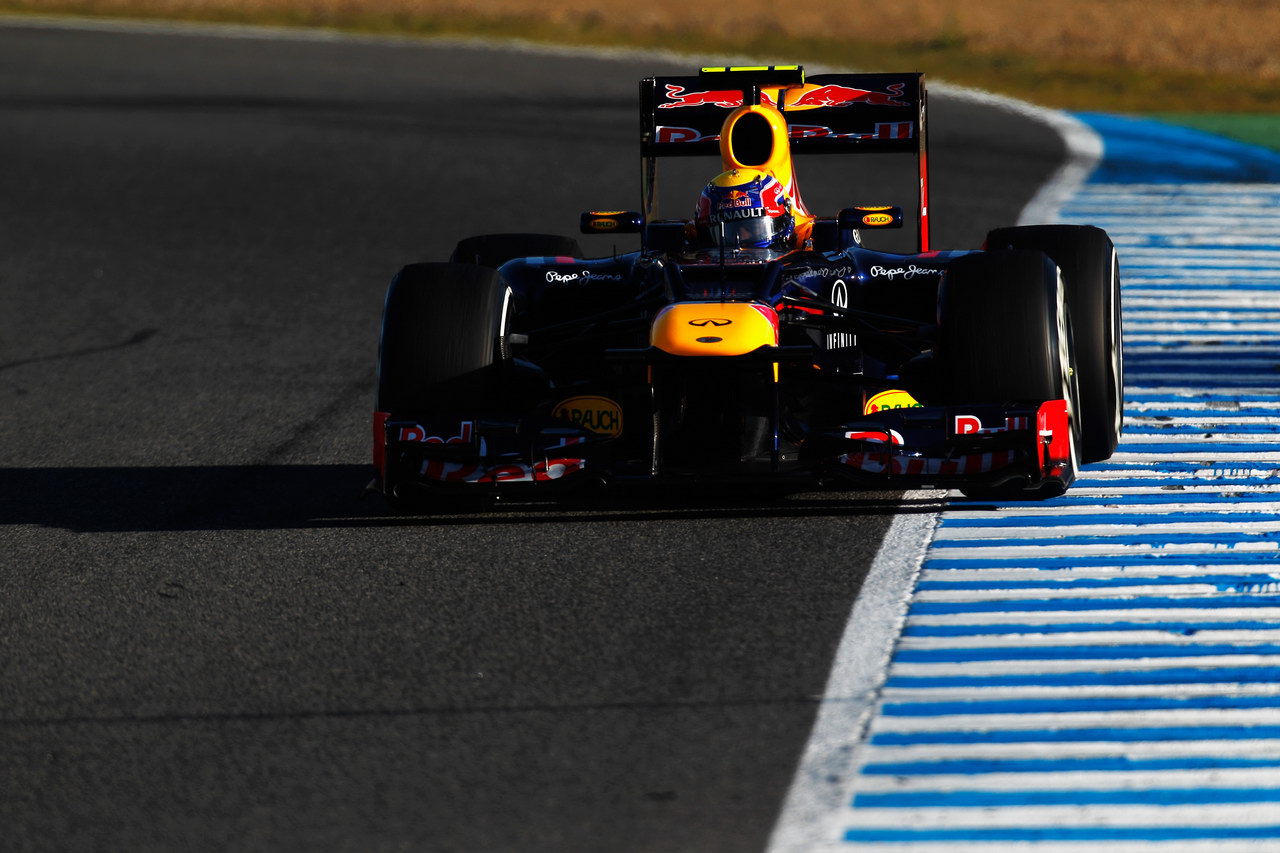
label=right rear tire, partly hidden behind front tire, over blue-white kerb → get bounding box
[987,225,1124,462]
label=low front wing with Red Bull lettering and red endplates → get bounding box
[374,400,1075,493]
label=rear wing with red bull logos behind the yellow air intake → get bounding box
[640,65,929,251]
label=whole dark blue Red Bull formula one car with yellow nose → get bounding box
[374,67,1123,505]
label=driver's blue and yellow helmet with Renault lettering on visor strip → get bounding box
[695,169,796,251]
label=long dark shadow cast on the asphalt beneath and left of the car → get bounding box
[0,465,942,533]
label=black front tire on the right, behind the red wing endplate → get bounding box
[937,245,1078,500]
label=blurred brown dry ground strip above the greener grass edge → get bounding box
[23,0,1280,78]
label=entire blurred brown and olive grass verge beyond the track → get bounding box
[0,0,1280,113]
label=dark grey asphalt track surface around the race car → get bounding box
[0,23,1062,852]
